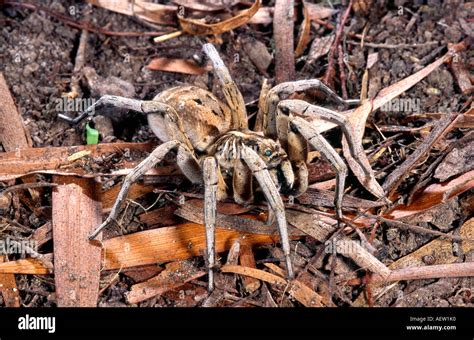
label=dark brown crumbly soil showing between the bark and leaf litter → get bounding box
[0,0,474,307]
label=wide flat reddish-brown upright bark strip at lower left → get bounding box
[52,177,102,307]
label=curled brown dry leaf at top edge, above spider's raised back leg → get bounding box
[178,0,260,35]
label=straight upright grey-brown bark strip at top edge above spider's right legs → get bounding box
[273,0,296,84]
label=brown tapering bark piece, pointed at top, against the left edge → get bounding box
[0,72,32,151]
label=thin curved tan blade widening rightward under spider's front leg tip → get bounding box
[221,265,323,307]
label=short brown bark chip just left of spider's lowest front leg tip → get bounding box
[127,261,206,303]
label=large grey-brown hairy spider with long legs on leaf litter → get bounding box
[61,44,369,291]
